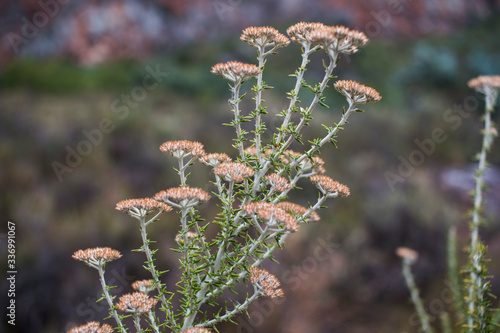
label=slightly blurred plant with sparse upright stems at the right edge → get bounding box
[397,76,500,333]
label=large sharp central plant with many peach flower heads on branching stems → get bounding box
[66,22,381,333]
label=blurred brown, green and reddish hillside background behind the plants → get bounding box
[0,0,500,333]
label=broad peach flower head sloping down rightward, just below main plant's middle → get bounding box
[243,202,299,232]
